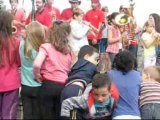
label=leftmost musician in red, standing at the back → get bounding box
[9,0,26,39]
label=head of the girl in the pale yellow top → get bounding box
[144,21,155,33]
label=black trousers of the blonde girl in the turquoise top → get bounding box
[21,85,40,119]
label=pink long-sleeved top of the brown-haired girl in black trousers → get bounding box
[33,43,73,84]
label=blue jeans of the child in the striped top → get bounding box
[140,103,160,120]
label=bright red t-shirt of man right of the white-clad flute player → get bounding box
[84,9,105,40]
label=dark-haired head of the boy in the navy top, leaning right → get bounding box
[78,45,99,65]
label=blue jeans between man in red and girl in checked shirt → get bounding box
[99,38,108,53]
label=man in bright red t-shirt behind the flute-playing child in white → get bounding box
[84,0,104,49]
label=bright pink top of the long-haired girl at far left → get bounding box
[0,39,21,92]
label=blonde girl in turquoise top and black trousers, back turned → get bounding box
[19,22,45,119]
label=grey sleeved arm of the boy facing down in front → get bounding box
[61,96,87,117]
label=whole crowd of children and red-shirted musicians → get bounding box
[0,0,160,119]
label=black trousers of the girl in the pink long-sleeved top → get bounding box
[40,80,64,119]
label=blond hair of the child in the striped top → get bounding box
[143,66,160,82]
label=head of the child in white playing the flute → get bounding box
[73,8,84,21]
